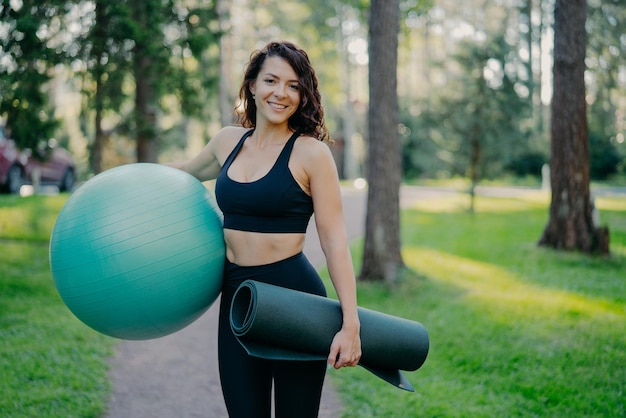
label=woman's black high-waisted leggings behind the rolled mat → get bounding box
[218,253,326,418]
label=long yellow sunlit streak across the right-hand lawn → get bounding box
[403,248,626,321]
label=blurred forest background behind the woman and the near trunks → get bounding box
[0,0,626,185]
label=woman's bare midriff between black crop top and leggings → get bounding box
[224,229,305,266]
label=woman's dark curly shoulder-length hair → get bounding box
[236,41,329,141]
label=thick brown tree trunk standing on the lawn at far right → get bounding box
[539,0,609,254]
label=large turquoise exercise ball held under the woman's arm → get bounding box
[49,163,225,340]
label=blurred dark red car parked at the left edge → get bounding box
[0,130,76,193]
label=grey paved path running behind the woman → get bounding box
[104,190,366,418]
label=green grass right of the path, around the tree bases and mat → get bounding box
[322,194,626,418]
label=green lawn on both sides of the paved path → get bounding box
[0,190,626,418]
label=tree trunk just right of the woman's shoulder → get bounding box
[360,0,404,283]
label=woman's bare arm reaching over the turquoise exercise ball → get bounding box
[165,127,240,181]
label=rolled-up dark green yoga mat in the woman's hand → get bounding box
[230,280,429,392]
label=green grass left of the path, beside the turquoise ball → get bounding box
[0,195,112,418]
